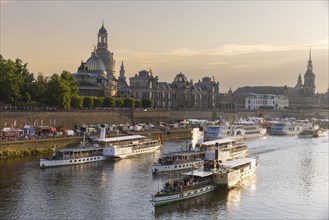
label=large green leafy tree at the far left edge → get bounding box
[0,55,24,103]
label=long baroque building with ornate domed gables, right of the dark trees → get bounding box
[130,70,219,110]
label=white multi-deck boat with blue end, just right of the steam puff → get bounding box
[204,122,266,141]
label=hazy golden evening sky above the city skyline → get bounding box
[0,0,329,93]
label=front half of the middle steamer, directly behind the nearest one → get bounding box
[151,151,205,174]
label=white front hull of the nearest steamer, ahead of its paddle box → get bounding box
[152,185,216,207]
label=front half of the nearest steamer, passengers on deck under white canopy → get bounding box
[151,170,216,206]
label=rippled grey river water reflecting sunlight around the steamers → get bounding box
[0,136,329,219]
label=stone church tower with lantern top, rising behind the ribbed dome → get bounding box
[96,21,115,79]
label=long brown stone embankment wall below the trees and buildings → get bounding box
[0,110,329,128]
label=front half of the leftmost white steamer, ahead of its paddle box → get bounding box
[40,147,108,168]
